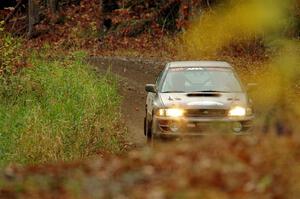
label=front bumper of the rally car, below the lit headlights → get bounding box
[152,116,254,138]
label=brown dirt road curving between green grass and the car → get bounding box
[89,57,164,146]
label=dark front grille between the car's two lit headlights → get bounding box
[185,109,228,117]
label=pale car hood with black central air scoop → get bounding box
[159,92,248,109]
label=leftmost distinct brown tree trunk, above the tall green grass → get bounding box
[27,0,39,38]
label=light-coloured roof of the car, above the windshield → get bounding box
[167,61,232,68]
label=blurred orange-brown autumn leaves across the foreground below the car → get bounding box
[0,136,300,199]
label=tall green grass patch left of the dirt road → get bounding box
[0,52,122,166]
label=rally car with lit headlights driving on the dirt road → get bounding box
[144,61,254,140]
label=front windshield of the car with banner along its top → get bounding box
[161,67,242,93]
